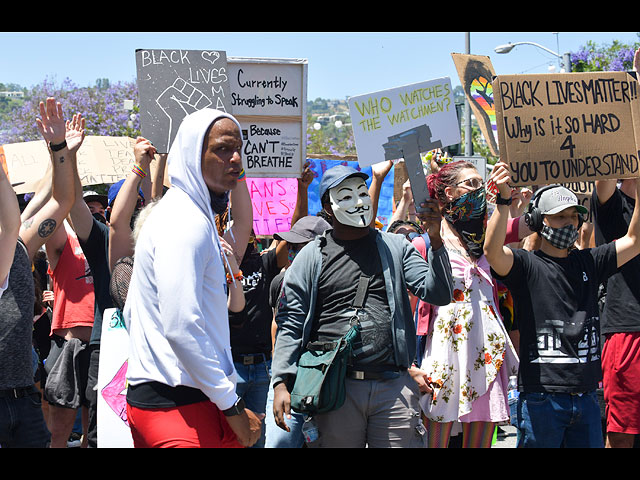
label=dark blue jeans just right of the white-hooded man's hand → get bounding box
[233,360,271,448]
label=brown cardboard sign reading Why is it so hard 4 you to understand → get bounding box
[493,72,640,186]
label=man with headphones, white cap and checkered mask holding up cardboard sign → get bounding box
[484,163,640,448]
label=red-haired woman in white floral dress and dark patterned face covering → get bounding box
[420,162,518,447]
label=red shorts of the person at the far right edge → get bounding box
[602,332,640,434]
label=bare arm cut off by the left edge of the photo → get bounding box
[0,167,20,284]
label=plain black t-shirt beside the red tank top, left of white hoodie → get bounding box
[78,218,115,345]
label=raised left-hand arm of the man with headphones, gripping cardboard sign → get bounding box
[484,162,513,276]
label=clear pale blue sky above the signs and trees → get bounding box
[0,32,640,100]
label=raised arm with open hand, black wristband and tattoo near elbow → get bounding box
[20,98,75,259]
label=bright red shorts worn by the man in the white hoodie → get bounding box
[127,401,242,448]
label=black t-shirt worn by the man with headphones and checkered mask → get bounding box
[492,244,617,392]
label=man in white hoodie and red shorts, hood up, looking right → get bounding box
[124,109,261,447]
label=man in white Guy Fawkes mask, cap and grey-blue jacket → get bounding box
[272,165,452,447]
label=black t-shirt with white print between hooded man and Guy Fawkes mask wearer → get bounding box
[229,248,280,354]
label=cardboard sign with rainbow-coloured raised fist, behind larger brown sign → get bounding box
[451,53,500,156]
